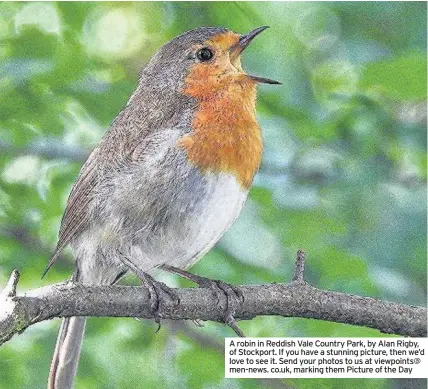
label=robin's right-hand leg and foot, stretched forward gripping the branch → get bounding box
[160,265,245,337]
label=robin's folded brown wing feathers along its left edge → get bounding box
[42,148,98,278]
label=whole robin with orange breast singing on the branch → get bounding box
[45,26,279,389]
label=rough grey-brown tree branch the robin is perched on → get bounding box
[0,251,427,345]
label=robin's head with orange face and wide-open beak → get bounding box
[143,26,280,98]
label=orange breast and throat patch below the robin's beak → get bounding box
[179,65,262,188]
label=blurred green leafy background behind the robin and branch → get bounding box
[0,2,427,389]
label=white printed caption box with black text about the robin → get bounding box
[225,338,428,378]
